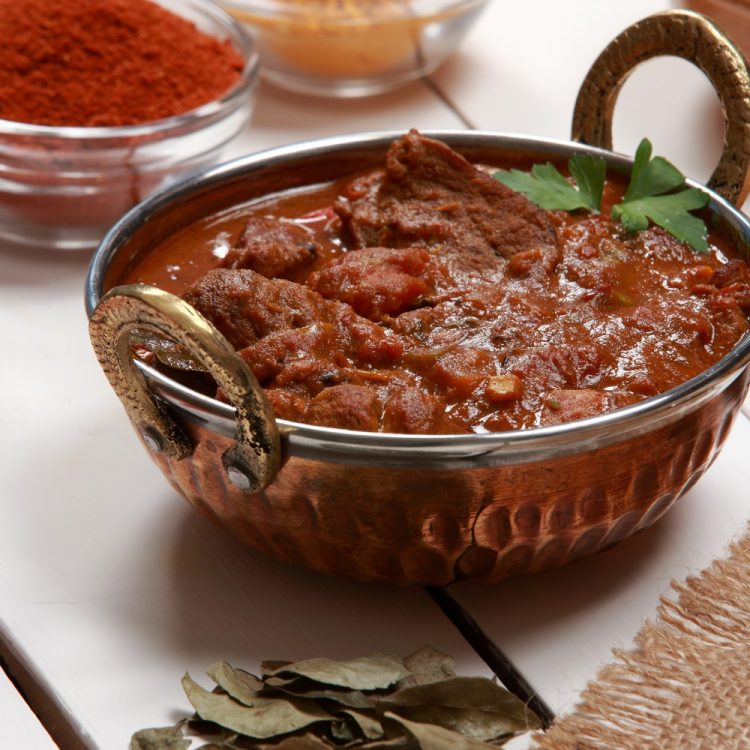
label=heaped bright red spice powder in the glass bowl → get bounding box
[0,0,244,126]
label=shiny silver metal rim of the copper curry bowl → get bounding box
[86,130,750,469]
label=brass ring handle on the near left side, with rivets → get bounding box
[89,284,281,492]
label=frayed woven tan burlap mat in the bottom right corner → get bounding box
[533,529,750,750]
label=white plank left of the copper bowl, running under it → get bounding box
[0,79,488,747]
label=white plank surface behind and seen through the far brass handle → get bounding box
[433,0,723,180]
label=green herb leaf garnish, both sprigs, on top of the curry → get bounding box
[494,138,709,253]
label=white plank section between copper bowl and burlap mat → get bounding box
[449,416,750,712]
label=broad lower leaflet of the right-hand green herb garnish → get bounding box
[612,188,708,253]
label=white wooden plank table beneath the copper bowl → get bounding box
[0,0,750,749]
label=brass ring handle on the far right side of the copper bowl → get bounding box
[572,10,750,206]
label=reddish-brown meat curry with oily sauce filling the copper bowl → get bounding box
[123,133,750,433]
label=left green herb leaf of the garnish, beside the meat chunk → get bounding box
[494,157,604,211]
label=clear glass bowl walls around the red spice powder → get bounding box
[0,0,258,250]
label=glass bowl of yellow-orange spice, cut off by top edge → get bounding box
[220,0,488,96]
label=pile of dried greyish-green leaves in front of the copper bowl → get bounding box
[137,646,540,750]
